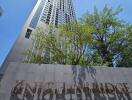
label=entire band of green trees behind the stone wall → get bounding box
[26,5,132,67]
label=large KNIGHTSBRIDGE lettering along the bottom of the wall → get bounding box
[10,80,132,100]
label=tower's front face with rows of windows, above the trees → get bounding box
[40,0,76,25]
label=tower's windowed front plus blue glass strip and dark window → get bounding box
[25,0,76,38]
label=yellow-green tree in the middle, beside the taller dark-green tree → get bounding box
[59,24,94,65]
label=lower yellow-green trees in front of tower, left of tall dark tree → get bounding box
[26,23,98,65]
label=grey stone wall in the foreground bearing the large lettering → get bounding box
[0,63,132,100]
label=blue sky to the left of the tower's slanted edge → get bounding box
[0,0,37,64]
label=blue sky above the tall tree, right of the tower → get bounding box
[73,0,132,23]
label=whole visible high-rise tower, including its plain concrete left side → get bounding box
[0,0,76,74]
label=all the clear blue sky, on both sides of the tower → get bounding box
[0,0,132,64]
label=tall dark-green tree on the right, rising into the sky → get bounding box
[81,5,132,67]
